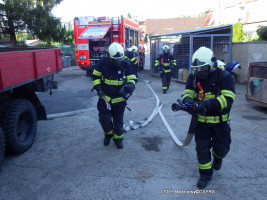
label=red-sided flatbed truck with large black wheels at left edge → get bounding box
[0,48,62,165]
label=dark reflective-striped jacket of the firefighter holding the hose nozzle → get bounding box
[182,68,235,124]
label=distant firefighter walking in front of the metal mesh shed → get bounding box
[155,45,176,94]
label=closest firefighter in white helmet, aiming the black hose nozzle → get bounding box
[182,47,235,189]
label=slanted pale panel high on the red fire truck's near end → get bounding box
[81,26,110,38]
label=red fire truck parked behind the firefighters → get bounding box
[74,16,145,76]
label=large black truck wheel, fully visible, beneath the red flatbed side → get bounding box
[2,99,37,154]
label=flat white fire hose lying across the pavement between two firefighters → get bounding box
[123,81,197,146]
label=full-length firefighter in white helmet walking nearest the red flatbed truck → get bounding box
[92,42,137,149]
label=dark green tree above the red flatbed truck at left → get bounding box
[0,0,64,46]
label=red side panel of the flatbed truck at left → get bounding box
[0,49,62,91]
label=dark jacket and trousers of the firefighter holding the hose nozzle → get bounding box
[182,69,235,176]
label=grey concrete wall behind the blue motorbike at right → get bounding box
[232,42,267,83]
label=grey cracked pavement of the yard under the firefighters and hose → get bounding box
[0,53,267,200]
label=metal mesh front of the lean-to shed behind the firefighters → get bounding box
[150,31,232,82]
